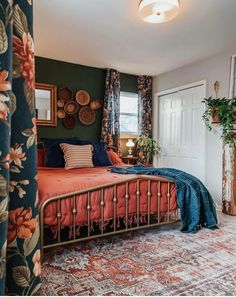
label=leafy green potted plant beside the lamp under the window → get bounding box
[137,135,160,165]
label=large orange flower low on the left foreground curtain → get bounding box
[7,207,37,244]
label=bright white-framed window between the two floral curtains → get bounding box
[120,92,138,136]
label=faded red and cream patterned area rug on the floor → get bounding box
[40,215,236,296]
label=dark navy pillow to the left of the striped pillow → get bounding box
[43,138,77,168]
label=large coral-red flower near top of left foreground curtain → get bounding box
[13,33,35,89]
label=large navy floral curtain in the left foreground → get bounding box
[0,0,40,295]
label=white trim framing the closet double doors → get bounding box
[153,80,207,182]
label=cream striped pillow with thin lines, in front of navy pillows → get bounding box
[60,143,94,169]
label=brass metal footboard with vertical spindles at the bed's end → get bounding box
[40,175,179,259]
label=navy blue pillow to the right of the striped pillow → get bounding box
[77,140,112,166]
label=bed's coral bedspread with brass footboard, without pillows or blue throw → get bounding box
[38,167,179,254]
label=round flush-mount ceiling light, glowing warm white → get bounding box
[139,0,179,23]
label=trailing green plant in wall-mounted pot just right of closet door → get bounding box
[202,97,229,130]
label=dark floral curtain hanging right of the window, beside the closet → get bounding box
[138,75,152,164]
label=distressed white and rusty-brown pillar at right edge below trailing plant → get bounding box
[222,134,236,216]
